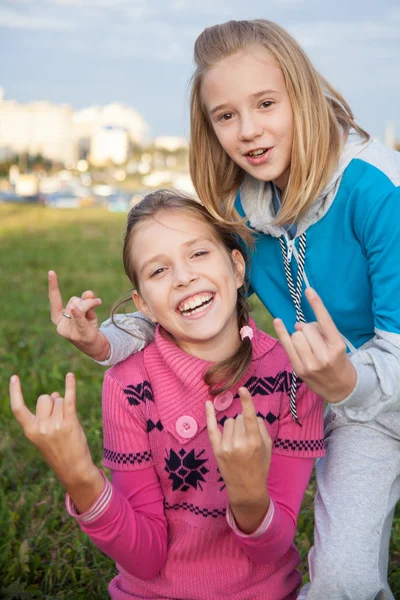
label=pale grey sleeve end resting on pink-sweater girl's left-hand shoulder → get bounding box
[96,312,155,366]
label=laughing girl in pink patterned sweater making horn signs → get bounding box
[10,191,324,600]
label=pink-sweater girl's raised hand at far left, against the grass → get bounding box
[10,373,104,512]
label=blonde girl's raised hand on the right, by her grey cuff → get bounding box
[274,288,357,403]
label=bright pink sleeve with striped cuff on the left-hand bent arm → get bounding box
[66,467,167,579]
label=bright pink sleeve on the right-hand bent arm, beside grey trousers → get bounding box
[227,454,314,563]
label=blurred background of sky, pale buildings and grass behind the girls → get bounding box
[0,0,400,600]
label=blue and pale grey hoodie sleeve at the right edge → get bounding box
[335,183,400,422]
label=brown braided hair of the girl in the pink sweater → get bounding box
[112,190,252,395]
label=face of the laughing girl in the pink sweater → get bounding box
[131,210,245,362]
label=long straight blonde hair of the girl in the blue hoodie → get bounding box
[189,19,369,225]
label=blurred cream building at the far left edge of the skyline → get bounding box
[0,89,75,164]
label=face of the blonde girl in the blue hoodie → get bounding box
[201,45,293,190]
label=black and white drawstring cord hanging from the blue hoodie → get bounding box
[279,232,307,426]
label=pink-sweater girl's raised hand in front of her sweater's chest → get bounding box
[206,388,272,533]
